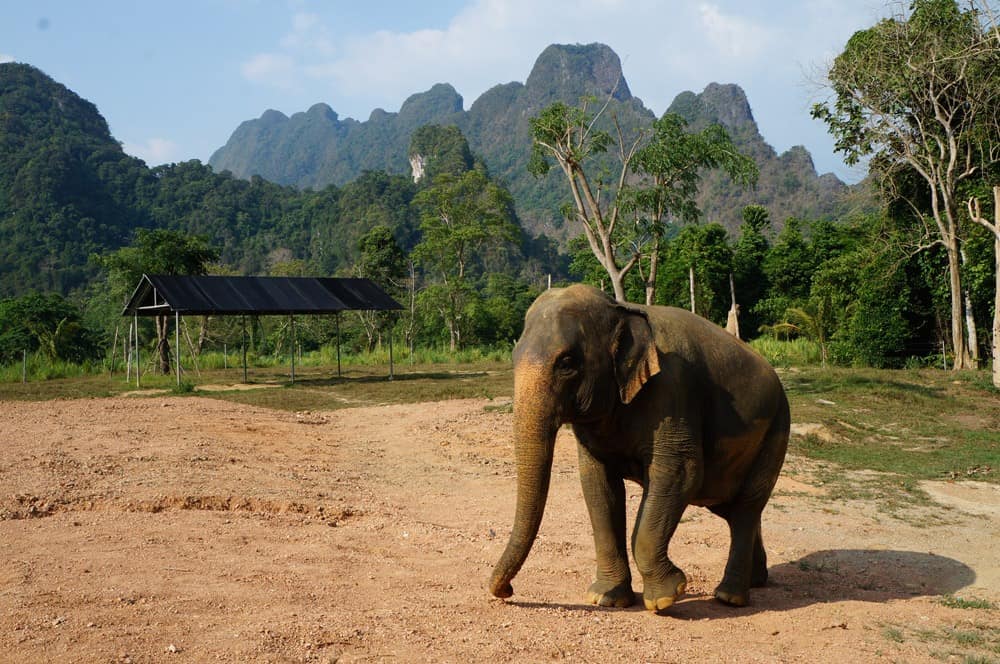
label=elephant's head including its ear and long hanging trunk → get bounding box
[490,285,660,597]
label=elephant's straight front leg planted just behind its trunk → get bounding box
[577,444,635,607]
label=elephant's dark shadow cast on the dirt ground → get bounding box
[521,549,976,620]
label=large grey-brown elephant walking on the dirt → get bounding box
[489,284,790,614]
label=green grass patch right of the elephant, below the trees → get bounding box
[782,368,1000,486]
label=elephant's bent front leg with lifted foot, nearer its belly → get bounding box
[632,436,702,613]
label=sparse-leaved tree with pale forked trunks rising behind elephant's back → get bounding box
[528,98,757,302]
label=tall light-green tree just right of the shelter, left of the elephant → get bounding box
[413,170,518,351]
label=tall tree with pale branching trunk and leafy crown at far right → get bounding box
[813,0,1000,370]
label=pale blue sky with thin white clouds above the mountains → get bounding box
[0,0,889,182]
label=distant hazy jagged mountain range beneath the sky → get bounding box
[209,44,868,241]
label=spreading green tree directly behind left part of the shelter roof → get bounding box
[96,229,219,374]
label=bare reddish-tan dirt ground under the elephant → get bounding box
[0,396,1000,662]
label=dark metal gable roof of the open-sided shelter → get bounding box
[122,274,403,316]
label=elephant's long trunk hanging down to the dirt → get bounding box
[490,365,559,597]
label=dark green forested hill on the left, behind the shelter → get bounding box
[0,63,428,297]
